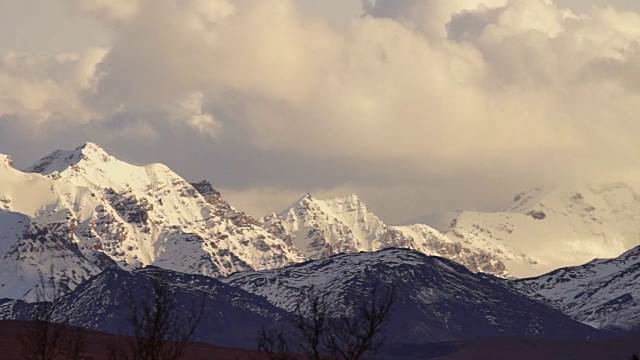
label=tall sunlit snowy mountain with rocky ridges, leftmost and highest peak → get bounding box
[0,143,305,298]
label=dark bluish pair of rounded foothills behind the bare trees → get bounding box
[0,249,598,348]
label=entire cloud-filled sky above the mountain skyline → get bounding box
[0,0,640,223]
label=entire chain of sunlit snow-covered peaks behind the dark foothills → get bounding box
[5,143,640,299]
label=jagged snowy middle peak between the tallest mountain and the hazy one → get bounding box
[263,194,509,276]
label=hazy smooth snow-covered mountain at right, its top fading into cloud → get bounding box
[446,183,640,277]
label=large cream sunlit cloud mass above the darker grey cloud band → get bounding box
[0,0,640,221]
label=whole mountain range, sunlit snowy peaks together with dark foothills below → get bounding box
[0,143,640,341]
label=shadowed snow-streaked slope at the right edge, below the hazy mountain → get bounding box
[517,246,640,330]
